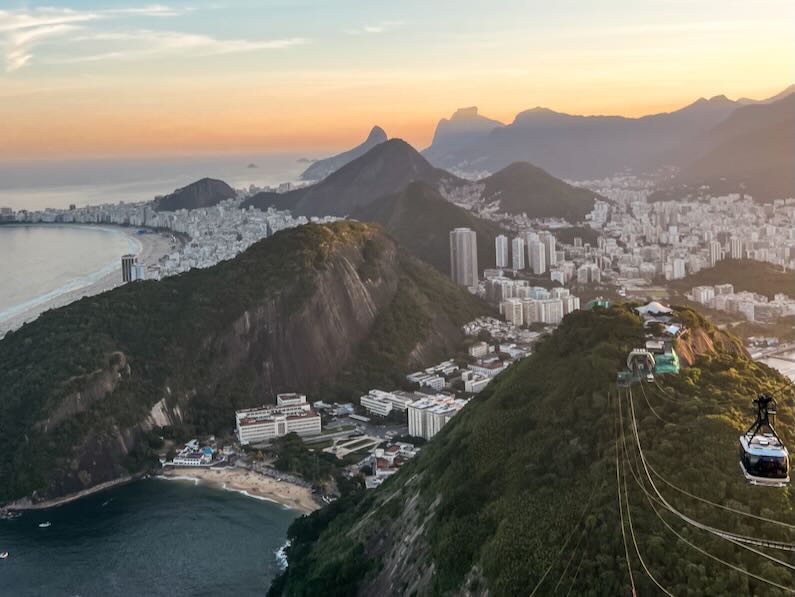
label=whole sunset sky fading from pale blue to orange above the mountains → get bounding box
[0,0,795,160]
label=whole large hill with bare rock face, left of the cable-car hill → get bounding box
[0,222,491,503]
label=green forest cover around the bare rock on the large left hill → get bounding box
[0,222,486,502]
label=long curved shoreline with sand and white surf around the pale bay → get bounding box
[0,223,171,339]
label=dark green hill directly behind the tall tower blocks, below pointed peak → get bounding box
[352,182,503,275]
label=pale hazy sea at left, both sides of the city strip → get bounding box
[0,154,307,327]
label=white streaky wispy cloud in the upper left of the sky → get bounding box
[0,4,309,72]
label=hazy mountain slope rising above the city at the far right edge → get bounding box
[676,93,795,200]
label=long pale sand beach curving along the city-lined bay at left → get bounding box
[0,224,173,338]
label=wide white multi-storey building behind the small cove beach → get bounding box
[235,394,321,445]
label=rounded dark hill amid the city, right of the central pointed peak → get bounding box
[478,162,602,222]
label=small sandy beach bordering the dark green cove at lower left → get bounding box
[162,467,320,513]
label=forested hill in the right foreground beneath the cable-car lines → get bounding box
[271,306,795,596]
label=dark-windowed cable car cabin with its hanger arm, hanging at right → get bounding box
[740,394,789,487]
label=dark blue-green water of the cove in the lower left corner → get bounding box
[0,479,298,597]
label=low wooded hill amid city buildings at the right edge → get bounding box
[669,259,795,298]
